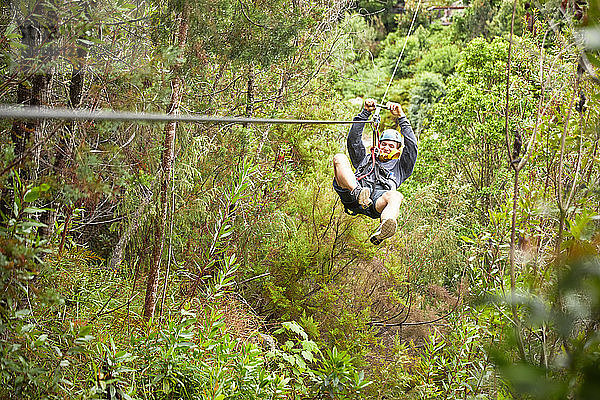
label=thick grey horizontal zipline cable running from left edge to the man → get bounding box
[0,104,370,125]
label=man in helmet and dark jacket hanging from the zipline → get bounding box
[333,99,417,245]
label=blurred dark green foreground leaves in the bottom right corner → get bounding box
[494,255,600,399]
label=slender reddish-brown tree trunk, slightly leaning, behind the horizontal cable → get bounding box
[144,10,188,319]
